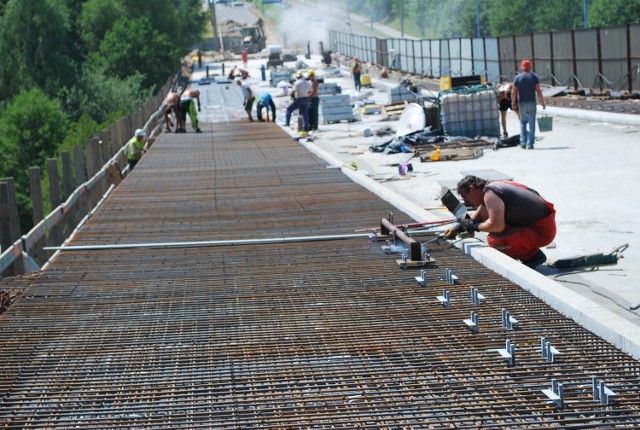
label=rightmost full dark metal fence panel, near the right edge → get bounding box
[600,25,629,91]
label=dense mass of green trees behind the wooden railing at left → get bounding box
[0,0,208,231]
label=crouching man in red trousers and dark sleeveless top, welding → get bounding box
[445,176,556,268]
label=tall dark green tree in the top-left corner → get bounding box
[0,0,76,99]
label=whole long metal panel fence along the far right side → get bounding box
[329,24,640,91]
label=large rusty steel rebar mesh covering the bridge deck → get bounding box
[0,123,640,429]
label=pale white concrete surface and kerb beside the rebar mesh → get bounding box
[193,49,640,358]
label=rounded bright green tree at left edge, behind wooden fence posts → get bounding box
[0,88,67,229]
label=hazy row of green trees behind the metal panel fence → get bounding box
[344,0,640,39]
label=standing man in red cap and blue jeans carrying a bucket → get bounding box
[511,59,546,149]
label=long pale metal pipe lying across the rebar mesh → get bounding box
[44,233,370,251]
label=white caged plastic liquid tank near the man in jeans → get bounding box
[439,90,500,137]
